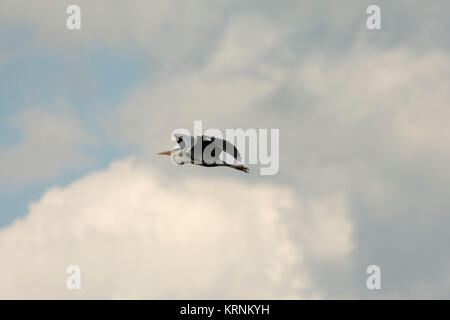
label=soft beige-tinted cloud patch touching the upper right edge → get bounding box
[295,42,450,147]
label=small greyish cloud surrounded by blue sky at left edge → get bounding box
[0,109,92,186]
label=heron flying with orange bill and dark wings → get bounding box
[158,134,249,173]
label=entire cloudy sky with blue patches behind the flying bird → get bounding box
[0,0,450,299]
